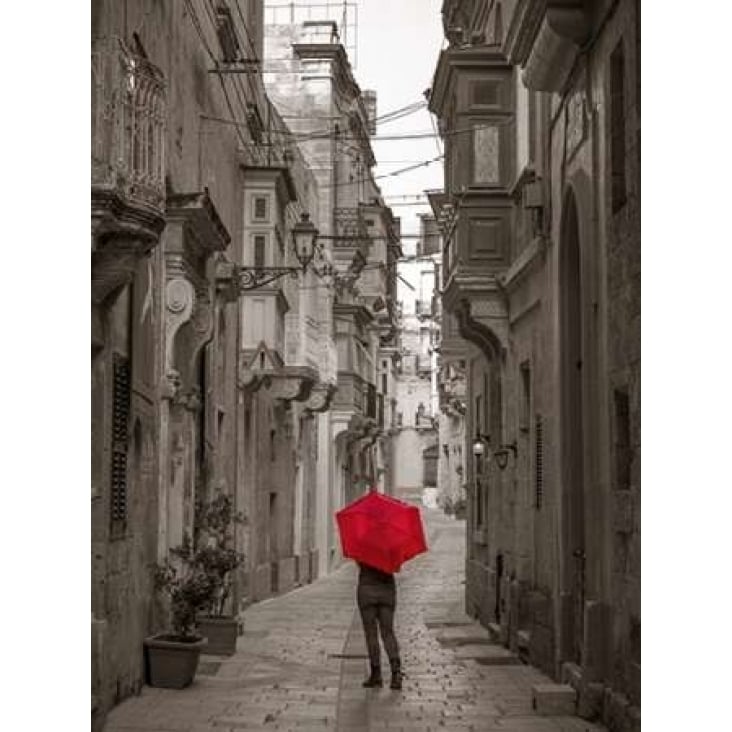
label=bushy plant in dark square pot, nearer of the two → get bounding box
[145,534,216,689]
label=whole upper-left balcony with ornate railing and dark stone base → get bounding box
[91,37,166,305]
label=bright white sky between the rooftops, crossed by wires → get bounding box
[349,0,444,311]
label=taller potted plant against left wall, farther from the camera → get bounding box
[196,493,244,656]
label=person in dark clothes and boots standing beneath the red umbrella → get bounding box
[357,562,402,690]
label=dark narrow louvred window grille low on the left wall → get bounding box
[110,353,131,525]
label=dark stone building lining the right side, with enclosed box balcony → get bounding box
[429,0,640,730]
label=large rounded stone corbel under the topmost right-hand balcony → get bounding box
[522,2,590,92]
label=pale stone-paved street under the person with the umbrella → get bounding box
[105,509,603,732]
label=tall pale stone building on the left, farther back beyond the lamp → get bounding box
[265,12,400,573]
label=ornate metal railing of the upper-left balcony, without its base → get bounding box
[92,37,166,208]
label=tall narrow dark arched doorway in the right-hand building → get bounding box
[559,189,586,664]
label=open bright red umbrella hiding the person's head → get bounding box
[336,491,427,573]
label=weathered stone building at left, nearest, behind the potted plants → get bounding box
[91,0,336,728]
